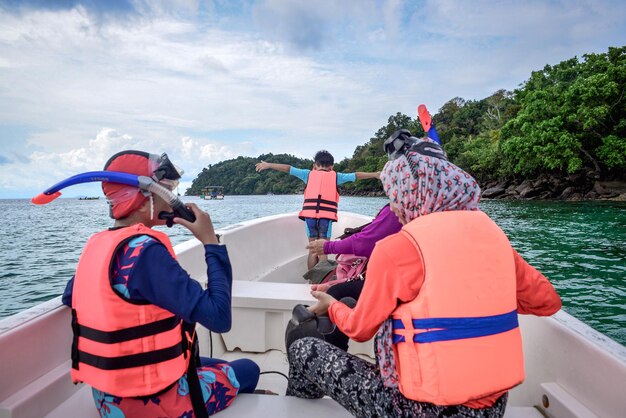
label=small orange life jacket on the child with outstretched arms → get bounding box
[298,170,339,221]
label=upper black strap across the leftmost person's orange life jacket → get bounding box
[72,316,180,344]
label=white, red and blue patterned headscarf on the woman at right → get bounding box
[380,138,480,221]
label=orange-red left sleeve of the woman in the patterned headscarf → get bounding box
[328,234,424,341]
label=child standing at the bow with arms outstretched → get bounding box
[256,150,380,270]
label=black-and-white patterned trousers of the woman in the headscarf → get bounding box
[287,337,508,418]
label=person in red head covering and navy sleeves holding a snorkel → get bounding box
[63,151,259,417]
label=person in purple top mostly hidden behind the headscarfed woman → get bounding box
[307,203,402,351]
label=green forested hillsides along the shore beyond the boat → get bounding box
[187,47,626,198]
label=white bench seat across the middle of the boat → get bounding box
[222,280,374,358]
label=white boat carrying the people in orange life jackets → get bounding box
[0,212,626,418]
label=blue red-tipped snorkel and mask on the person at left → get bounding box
[31,151,196,227]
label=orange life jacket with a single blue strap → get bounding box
[392,211,524,405]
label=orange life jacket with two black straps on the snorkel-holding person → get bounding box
[71,224,191,397]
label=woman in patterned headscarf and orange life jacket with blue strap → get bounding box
[287,135,561,417]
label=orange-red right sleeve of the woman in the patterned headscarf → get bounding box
[513,250,561,316]
